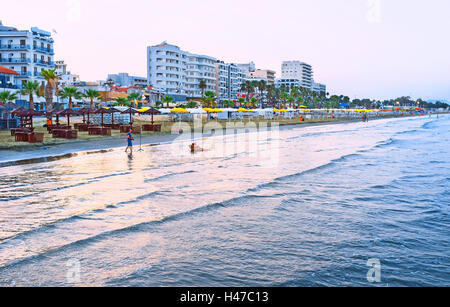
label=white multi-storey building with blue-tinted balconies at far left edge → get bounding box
[0,22,55,87]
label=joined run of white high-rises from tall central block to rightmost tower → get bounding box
[147,42,326,101]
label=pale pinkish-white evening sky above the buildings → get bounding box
[0,0,450,101]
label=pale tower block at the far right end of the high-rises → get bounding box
[279,61,314,90]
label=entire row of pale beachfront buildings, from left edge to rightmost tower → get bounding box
[0,21,326,106]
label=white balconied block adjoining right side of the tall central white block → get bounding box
[186,53,217,98]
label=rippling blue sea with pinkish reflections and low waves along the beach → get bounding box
[0,116,450,286]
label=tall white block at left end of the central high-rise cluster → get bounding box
[147,42,188,101]
